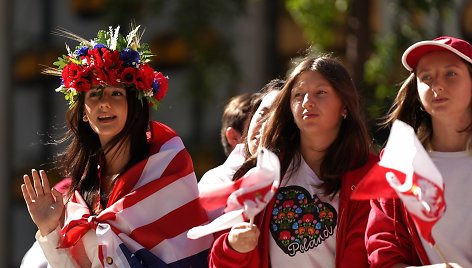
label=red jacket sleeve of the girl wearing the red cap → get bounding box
[365,196,430,267]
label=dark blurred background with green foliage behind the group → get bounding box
[0,0,472,267]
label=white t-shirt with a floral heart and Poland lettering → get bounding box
[268,158,339,268]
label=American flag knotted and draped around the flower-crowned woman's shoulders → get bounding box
[60,122,213,268]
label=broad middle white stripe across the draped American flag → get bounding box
[109,173,198,234]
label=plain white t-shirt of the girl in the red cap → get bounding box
[422,151,472,267]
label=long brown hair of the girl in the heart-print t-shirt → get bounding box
[237,55,370,195]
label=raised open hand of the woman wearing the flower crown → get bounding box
[21,169,64,236]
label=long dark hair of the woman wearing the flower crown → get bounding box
[58,90,149,209]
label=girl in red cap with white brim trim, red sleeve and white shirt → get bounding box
[366,36,472,267]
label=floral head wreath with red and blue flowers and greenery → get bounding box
[43,23,168,110]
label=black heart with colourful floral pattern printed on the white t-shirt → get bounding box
[270,185,337,256]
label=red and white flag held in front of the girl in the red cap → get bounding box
[351,120,446,245]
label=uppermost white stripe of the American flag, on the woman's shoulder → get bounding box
[133,136,185,190]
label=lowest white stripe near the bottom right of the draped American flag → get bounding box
[151,229,213,263]
